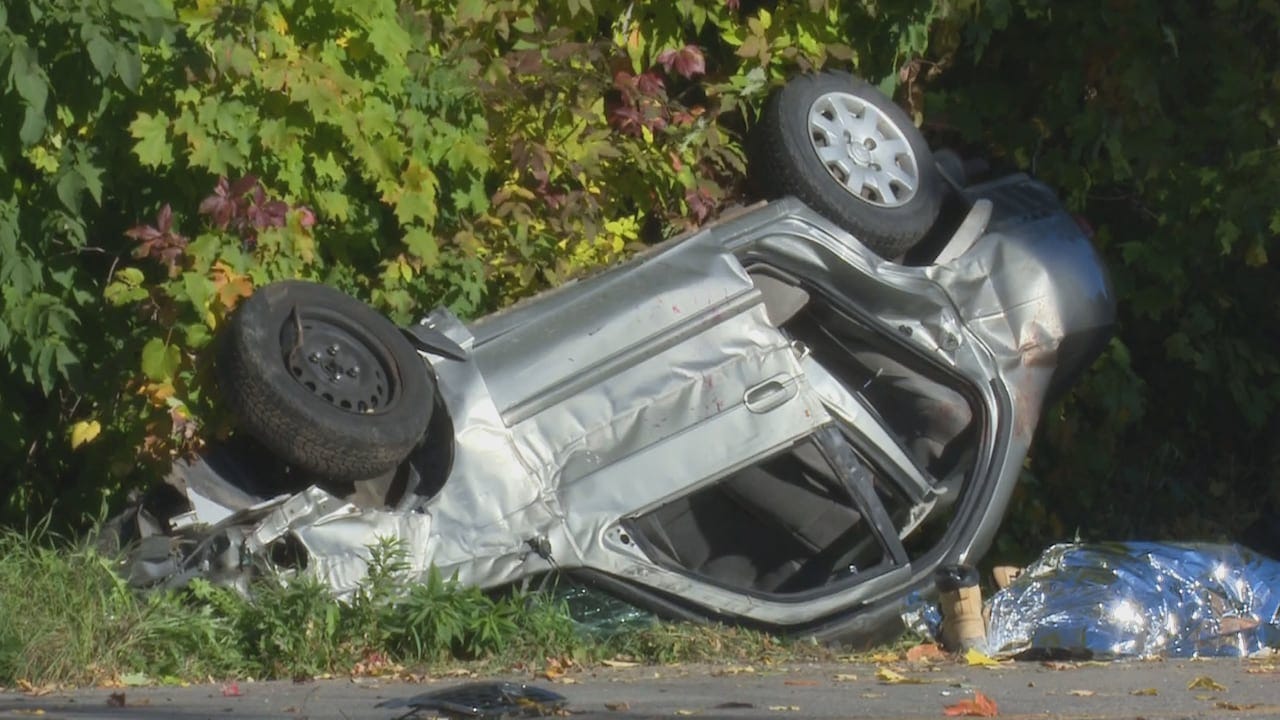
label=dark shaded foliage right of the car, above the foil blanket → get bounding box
[925,0,1280,548]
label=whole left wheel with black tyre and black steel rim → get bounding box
[216,281,435,482]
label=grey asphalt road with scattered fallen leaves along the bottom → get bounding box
[0,657,1280,720]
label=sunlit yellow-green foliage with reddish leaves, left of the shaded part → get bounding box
[0,0,901,521]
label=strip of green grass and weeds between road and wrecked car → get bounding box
[0,529,824,687]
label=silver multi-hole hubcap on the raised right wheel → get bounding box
[809,92,920,208]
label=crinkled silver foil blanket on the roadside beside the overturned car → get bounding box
[987,542,1280,659]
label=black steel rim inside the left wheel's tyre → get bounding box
[280,304,399,415]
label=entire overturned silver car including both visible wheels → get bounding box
[122,74,1115,641]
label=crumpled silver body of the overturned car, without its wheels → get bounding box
[131,174,1115,641]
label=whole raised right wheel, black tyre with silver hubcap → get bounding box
[749,72,945,259]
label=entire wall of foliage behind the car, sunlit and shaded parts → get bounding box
[0,0,1280,556]
